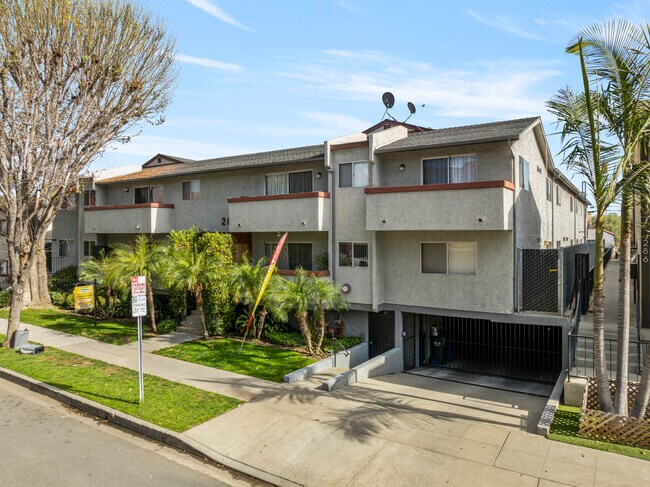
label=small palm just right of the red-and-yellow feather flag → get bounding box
[271,268,318,355]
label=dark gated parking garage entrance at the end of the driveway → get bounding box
[403,313,562,383]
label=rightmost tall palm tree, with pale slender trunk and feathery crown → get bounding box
[567,20,650,416]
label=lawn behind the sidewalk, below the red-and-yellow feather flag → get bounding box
[154,338,314,382]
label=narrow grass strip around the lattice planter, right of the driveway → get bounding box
[548,405,650,461]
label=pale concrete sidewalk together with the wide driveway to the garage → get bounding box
[0,321,650,486]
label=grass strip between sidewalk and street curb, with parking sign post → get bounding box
[0,335,241,432]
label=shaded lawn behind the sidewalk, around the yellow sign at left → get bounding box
[0,308,153,345]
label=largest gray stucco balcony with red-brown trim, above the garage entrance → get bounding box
[365,181,514,231]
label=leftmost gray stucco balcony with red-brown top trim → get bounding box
[84,203,174,234]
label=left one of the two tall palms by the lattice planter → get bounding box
[547,41,624,413]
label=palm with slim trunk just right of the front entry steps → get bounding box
[162,246,224,339]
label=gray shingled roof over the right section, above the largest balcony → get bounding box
[375,117,540,153]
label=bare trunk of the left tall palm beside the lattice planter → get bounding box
[594,221,614,413]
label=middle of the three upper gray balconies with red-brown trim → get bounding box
[228,191,330,232]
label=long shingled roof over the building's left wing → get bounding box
[101,144,325,183]
